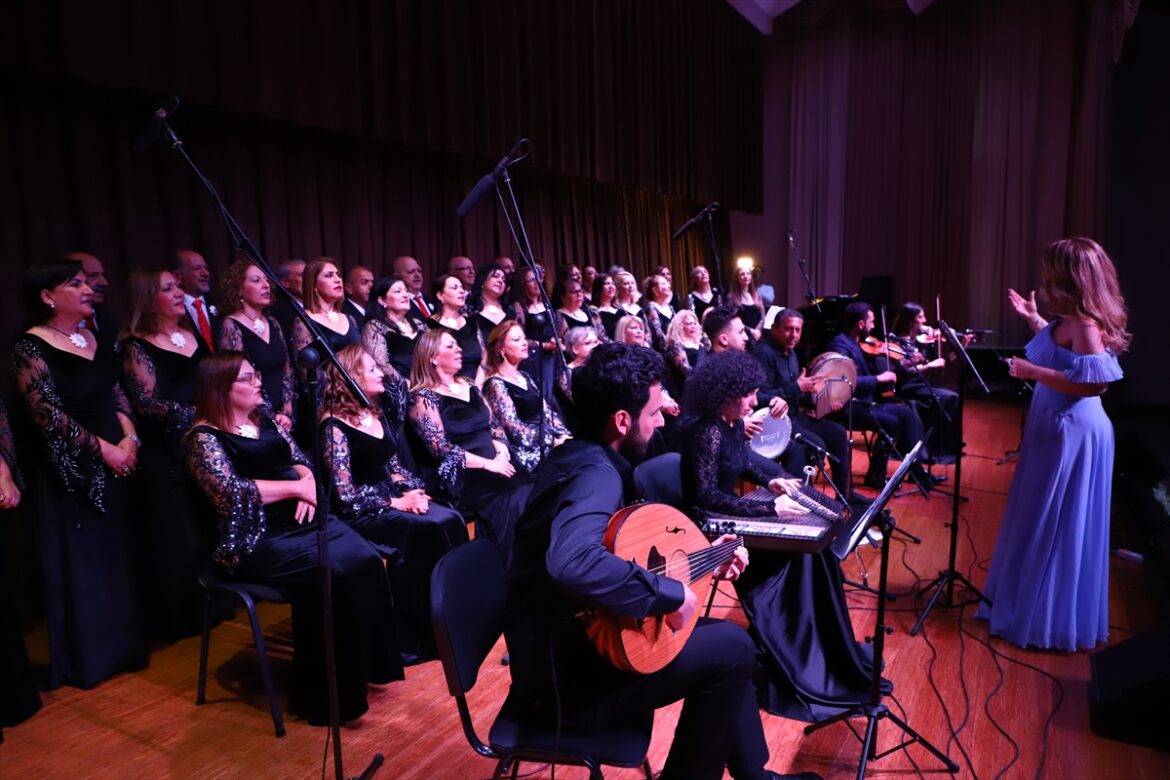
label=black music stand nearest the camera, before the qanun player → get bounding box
[804,441,958,780]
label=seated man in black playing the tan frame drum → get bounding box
[752,309,852,495]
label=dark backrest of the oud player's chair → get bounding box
[431,539,508,697]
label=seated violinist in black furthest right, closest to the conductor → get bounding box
[876,302,970,463]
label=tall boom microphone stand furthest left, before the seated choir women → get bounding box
[152,105,385,780]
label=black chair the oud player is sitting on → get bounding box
[431,539,653,780]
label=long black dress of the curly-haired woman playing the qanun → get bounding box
[681,420,889,722]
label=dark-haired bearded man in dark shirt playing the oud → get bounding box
[505,344,814,780]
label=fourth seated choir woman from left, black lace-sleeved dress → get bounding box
[483,320,576,474]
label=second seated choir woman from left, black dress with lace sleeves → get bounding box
[321,345,467,663]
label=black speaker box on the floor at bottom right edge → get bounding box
[1089,628,1170,750]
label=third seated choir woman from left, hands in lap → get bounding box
[408,330,532,561]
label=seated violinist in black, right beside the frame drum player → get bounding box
[828,301,944,488]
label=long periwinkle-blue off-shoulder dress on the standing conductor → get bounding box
[978,320,1122,650]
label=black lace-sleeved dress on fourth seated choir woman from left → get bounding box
[483,372,569,474]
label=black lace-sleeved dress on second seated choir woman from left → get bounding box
[321,417,467,664]
